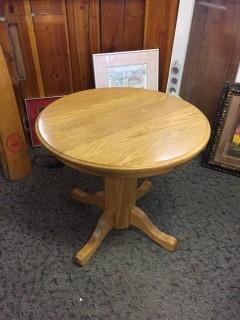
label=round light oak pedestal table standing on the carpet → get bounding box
[36,88,210,266]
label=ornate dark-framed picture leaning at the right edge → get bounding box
[203,83,240,176]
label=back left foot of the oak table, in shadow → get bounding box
[71,188,104,209]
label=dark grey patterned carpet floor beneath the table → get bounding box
[0,151,240,320]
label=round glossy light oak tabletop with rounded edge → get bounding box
[36,88,210,177]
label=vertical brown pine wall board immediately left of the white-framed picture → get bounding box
[66,0,100,91]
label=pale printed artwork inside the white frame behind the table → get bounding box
[107,63,147,89]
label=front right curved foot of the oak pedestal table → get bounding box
[130,207,177,251]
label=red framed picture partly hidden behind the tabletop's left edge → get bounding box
[25,96,61,147]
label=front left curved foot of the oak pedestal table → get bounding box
[74,212,114,266]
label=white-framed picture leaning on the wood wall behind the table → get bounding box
[93,49,159,90]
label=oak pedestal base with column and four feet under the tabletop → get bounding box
[72,176,177,266]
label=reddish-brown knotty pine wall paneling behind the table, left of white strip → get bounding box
[0,0,179,119]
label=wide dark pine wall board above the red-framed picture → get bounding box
[30,0,72,96]
